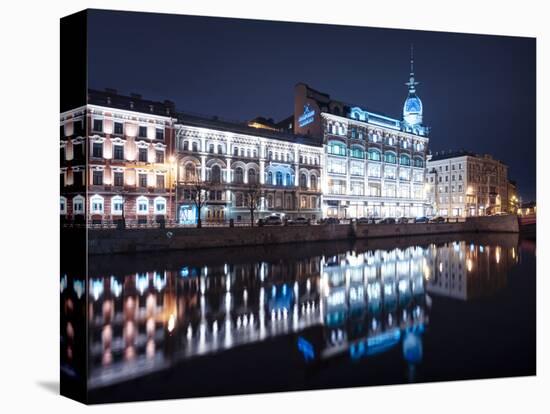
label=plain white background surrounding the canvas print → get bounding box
[0,0,550,414]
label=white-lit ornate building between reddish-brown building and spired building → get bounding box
[176,114,322,224]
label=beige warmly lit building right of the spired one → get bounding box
[426,151,517,217]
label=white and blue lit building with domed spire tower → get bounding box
[294,52,429,218]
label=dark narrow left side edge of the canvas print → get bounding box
[60,11,88,403]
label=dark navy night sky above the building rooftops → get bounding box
[88,11,536,201]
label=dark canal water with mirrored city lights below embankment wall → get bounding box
[61,234,536,402]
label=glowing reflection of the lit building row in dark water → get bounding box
[61,239,518,388]
